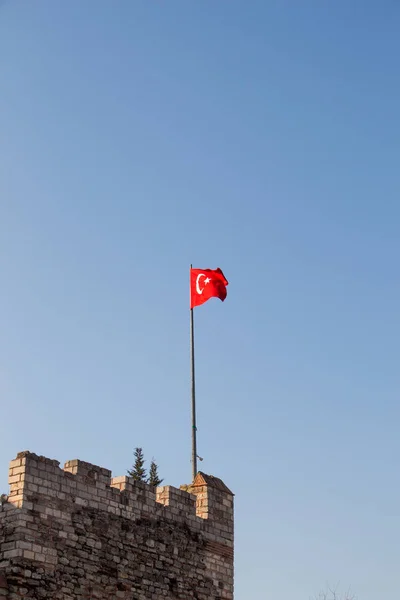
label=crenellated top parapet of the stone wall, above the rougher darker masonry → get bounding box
[8,451,233,545]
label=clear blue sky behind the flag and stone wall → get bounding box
[0,0,400,600]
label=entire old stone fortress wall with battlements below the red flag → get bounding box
[0,452,233,600]
